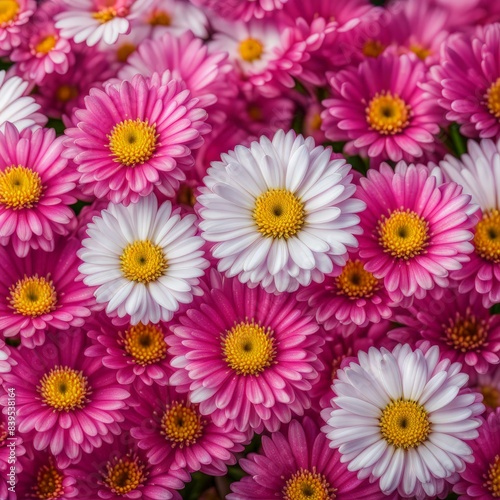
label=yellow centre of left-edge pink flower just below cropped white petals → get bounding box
[0,165,43,210]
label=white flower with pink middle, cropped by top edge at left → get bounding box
[55,0,152,47]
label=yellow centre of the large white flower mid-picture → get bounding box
[253,189,306,238]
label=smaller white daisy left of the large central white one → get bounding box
[78,195,208,324]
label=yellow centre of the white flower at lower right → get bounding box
[379,399,431,450]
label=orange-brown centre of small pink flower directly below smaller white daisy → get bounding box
[123,323,168,366]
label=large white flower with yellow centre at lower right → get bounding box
[322,343,484,499]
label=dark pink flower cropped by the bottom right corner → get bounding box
[453,412,500,500]
